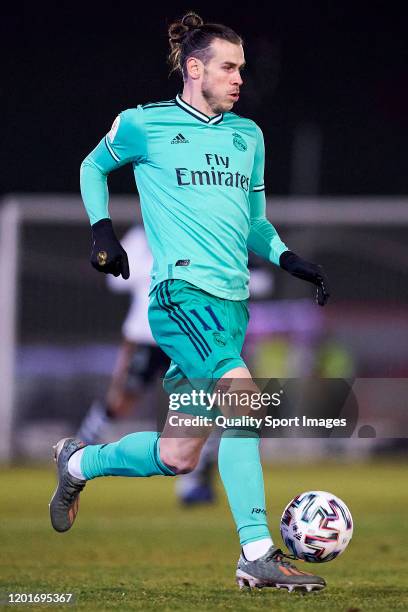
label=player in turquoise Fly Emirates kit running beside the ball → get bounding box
[50,13,329,591]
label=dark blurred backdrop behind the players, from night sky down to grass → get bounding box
[0,2,408,461]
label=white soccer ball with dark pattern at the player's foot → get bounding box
[280,491,353,563]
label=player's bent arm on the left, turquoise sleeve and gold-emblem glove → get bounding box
[80,108,147,278]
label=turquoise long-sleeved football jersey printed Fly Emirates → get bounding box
[81,95,287,300]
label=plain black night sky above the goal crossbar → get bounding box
[1,2,408,195]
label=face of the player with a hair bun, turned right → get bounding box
[201,38,245,114]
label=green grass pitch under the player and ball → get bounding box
[0,461,408,612]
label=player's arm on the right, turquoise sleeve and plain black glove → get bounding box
[247,128,330,306]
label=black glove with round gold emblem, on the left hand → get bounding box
[91,219,129,279]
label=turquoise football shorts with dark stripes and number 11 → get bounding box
[149,279,249,418]
